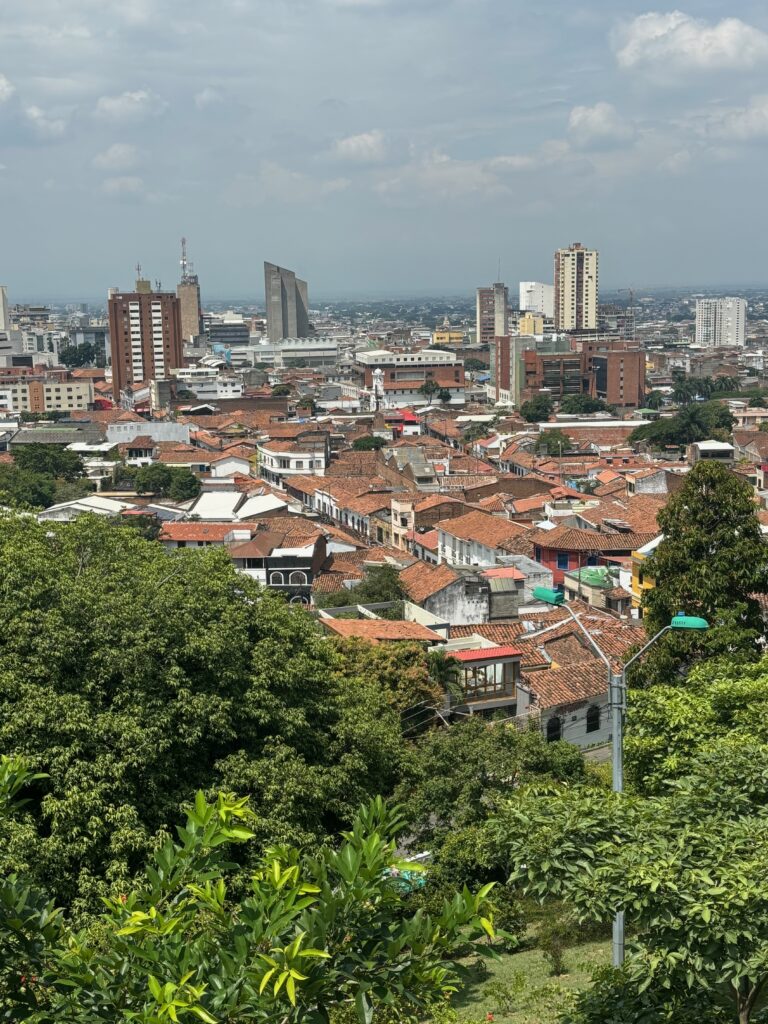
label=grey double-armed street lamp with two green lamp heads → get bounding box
[534,587,710,967]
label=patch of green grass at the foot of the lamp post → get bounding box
[454,940,610,1024]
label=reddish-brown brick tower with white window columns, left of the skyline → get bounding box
[108,278,182,401]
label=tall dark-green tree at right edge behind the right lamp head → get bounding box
[643,462,768,681]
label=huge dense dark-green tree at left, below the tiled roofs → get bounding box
[0,516,402,911]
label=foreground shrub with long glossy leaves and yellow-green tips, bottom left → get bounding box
[0,762,494,1024]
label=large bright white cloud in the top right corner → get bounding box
[616,10,768,71]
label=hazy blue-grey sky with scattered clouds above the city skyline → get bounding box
[0,0,768,302]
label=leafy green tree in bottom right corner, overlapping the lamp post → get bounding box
[486,746,768,1024]
